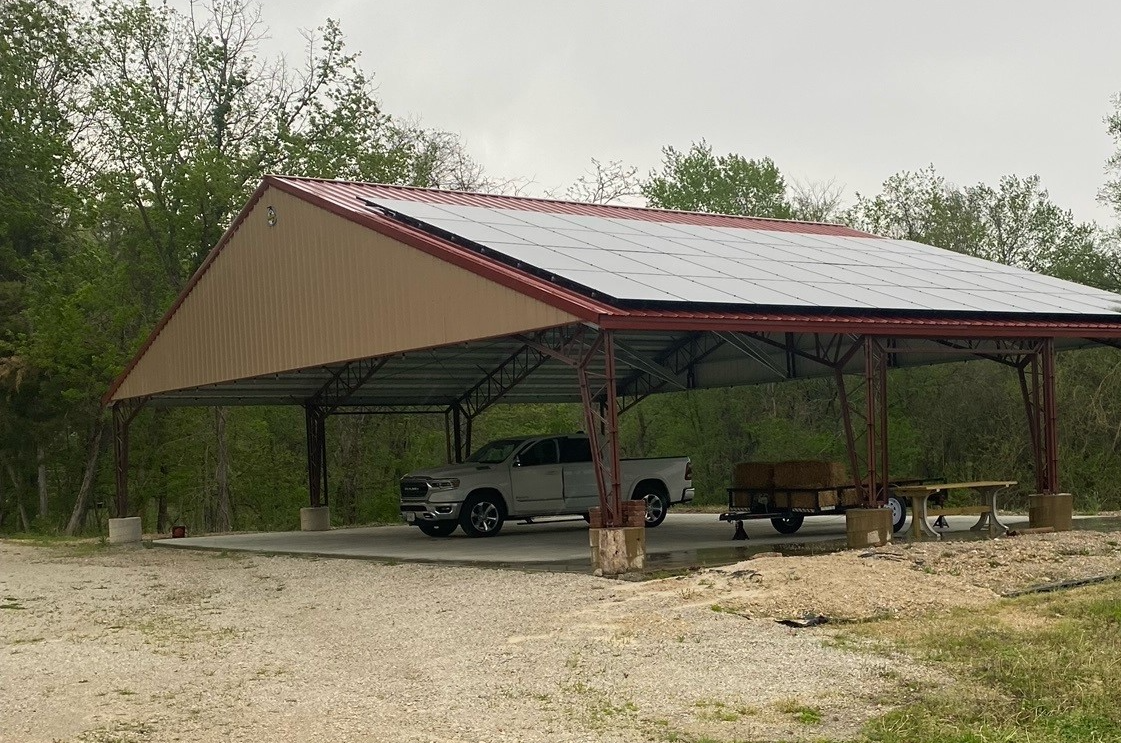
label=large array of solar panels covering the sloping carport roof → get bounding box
[371,198,1121,315]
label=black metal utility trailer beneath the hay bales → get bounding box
[720,477,942,540]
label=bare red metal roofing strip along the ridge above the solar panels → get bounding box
[269,176,877,238]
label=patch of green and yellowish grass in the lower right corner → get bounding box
[860,583,1121,743]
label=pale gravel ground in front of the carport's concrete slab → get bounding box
[0,532,1121,743]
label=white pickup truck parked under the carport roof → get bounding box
[401,434,693,537]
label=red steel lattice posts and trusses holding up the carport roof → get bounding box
[112,324,1058,527]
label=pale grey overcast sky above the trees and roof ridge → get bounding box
[241,0,1121,223]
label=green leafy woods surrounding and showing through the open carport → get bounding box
[0,0,1121,531]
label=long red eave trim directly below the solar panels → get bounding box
[599,310,1121,338]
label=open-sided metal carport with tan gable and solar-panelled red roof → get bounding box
[104,176,1121,569]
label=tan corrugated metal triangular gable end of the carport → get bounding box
[110,187,578,401]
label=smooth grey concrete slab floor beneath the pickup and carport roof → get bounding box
[144,513,1081,572]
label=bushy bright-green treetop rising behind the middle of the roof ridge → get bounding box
[641,140,793,220]
